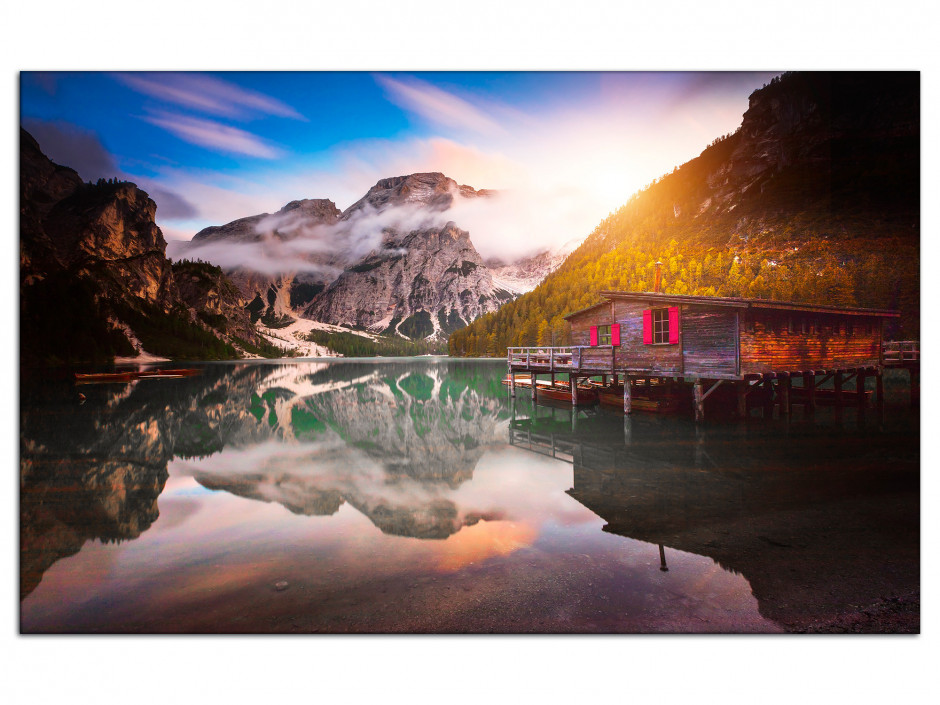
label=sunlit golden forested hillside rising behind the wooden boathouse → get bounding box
[449,73,920,356]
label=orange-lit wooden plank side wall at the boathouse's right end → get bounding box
[741,314,881,374]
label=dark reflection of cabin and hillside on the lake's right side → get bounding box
[509,406,920,632]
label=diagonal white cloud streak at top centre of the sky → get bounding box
[375,75,505,135]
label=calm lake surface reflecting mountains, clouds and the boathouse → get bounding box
[20,358,919,633]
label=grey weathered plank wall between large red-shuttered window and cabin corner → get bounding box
[680,306,737,378]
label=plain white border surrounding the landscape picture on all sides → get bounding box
[0,0,940,704]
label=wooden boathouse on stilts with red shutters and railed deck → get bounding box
[508,291,919,419]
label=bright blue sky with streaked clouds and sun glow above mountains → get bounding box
[21,72,774,256]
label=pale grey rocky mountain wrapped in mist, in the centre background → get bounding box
[180,172,567,339]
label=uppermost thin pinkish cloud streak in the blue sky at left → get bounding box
[117,73,307,121]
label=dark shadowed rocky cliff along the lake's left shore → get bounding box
[20,130,260,366]
